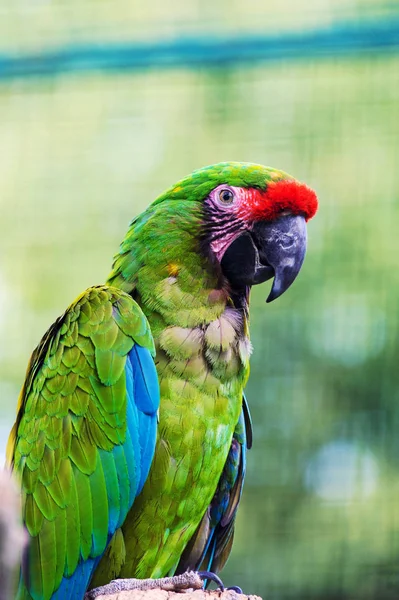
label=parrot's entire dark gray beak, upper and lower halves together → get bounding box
[221,215,307,302]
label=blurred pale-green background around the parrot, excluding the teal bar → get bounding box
[0,0,399,600]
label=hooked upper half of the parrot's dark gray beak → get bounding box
[251,215,307,302]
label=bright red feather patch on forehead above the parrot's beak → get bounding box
[240,179,318,221]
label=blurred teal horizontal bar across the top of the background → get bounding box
[0,19,399,80]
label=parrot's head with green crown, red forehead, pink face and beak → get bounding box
[156,162,317,302]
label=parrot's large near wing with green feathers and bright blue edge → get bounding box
[8,286,159,600]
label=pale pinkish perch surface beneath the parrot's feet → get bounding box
[89,589,261,600]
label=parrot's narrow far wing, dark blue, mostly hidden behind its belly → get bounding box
[176,395,252,573]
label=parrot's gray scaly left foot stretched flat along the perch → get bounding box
[85,571,205,600]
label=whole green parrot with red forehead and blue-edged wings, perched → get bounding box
[7,162,318,600]
